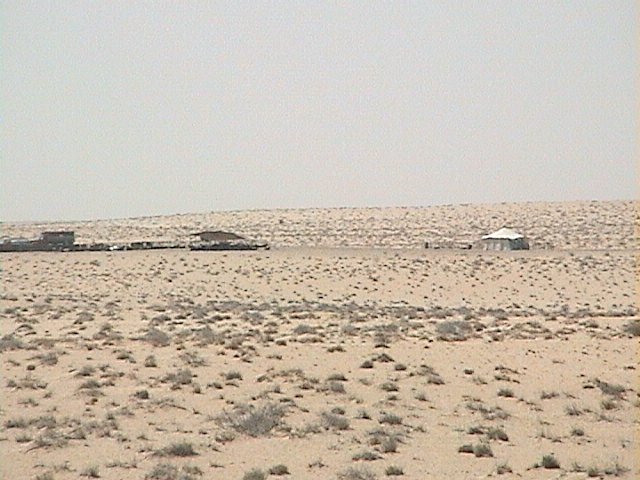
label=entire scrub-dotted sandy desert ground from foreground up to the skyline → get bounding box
[0,201,640,480]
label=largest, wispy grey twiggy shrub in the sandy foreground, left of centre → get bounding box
[218,403,285,437]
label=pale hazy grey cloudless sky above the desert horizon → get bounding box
[0,0,640,221]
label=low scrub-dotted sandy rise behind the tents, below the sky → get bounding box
[0,201,639,249]
